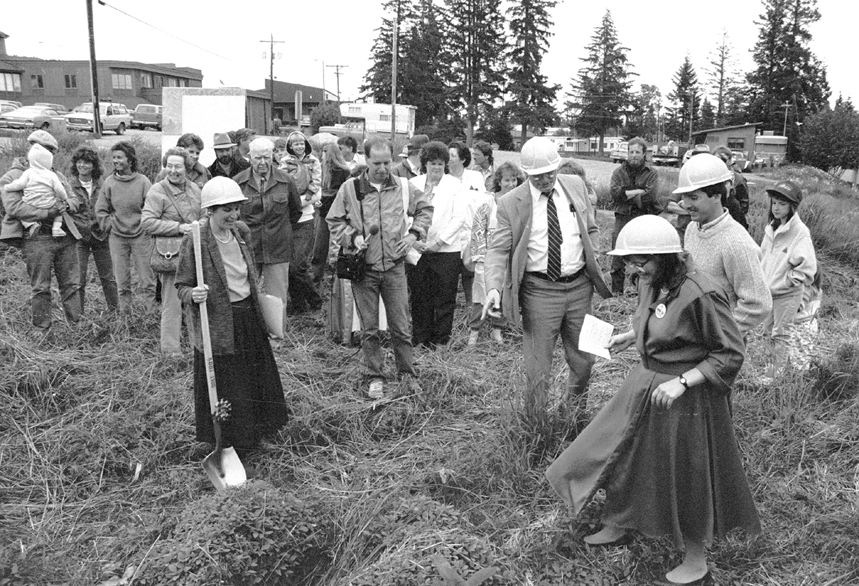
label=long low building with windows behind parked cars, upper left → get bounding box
[0,33,203,109]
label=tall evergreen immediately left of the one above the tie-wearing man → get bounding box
[446,0,504,146]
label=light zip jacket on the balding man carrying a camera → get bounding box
[325,171,433,271]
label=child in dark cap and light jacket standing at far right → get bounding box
[761,181,817,379]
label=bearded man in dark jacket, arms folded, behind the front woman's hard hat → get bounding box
[610,137,662,295]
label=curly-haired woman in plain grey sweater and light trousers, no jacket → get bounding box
[95,141,155,311]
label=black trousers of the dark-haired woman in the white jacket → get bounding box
[409,252,462,346]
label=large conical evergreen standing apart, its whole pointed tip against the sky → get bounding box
[566,10,634,154]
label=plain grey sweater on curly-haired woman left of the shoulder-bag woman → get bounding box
[95,173,152,238]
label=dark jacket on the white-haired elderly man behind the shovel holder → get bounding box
[233,169,301,265]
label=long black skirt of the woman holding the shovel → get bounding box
[194,298,289,449]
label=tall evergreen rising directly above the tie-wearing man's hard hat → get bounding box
[507,0,560,145]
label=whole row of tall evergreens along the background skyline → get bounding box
[360,0,852,167]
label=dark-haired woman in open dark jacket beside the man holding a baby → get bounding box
[69,146,119,311]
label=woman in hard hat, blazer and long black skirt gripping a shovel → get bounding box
[176,177,289,450]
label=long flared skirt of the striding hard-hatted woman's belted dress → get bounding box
[546,365,761,546]
